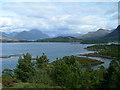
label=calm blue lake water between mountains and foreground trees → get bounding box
[0,43,110,70]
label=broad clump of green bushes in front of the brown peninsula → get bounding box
[52,56,99,88]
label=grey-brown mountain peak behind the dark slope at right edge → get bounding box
[79,29,111,40]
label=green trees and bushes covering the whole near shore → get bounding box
[2,45,120,89]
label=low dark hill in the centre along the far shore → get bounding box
[37,36,81,42]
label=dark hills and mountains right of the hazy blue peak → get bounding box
[38,25,120,44]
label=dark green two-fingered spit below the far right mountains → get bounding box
[84,44,120,58]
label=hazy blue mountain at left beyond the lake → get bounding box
[1,29,49,40]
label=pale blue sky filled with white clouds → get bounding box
[0,0,118,36]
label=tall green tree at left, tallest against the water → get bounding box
[14,53,35,82]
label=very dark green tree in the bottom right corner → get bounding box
[102,60,120,88]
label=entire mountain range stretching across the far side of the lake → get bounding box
[0,25,120,42]
